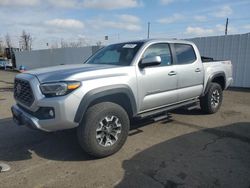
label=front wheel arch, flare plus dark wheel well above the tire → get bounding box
[74,85,137,123]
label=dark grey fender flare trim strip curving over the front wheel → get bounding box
[74,84,137,123]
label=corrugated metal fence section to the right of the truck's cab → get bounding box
[188,33,250,87]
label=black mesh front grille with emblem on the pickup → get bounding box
[14,79,34,106]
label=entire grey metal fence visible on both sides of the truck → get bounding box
[15,33,250,87]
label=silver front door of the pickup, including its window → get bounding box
[137,43,177,112]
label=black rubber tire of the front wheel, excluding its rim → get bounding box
[77,102,130,158]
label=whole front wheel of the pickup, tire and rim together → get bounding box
[77,102,130,157]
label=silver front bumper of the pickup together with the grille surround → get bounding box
[11,74,81,132]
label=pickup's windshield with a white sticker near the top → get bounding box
[86,42,143,66]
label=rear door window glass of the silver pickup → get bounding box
[174,44,196,64]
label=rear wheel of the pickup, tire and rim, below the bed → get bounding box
[200,83,223,114]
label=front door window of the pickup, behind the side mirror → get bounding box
[143,43,172,66]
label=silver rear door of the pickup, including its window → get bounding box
[172,43,204,102]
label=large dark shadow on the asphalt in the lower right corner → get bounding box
[116,122,250,188]
